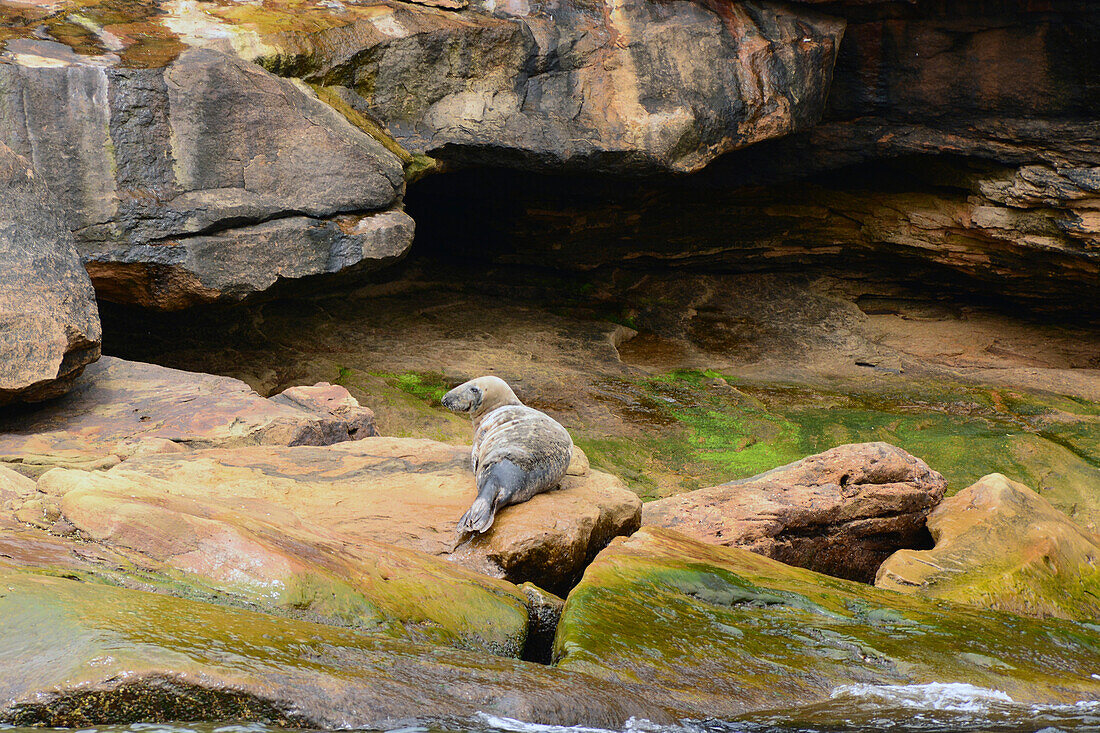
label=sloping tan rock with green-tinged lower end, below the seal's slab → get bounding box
[24,468,529,657]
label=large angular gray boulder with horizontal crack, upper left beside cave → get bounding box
[0,40,413,309]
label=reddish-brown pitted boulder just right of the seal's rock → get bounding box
[642,442,946,582]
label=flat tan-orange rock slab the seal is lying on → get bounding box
[39,438,641,592]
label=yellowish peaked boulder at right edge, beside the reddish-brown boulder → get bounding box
[875,473,1100,620]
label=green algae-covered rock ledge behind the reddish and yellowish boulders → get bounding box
[576,370,1100,527]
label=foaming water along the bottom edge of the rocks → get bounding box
[0,683,1100,733]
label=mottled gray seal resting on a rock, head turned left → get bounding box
[443,376,573,534]
